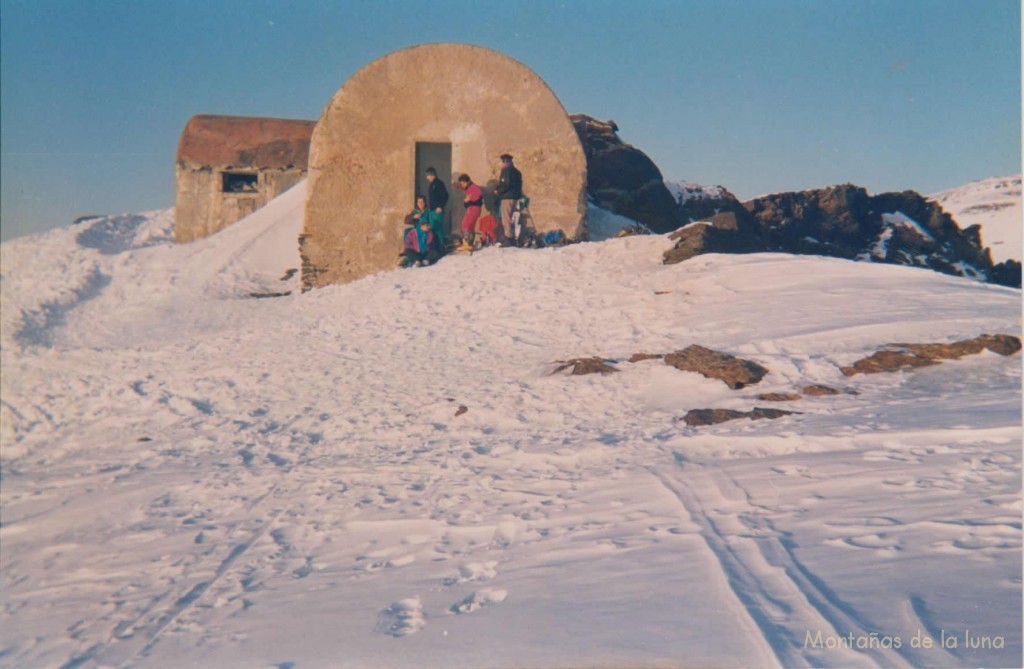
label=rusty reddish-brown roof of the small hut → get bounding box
[177,114,316,169]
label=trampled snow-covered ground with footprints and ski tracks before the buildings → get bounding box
[0,180,1022,669]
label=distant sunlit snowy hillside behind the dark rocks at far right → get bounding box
[930,174,1024,262]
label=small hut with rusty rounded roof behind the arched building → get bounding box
[174,115,316,242]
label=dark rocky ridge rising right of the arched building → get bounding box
[570,114,1021,288]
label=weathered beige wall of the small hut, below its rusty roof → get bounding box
[174,163,306,243]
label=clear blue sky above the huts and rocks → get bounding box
[0,0,1021,239]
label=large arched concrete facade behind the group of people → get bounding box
[300,44,587,289]
